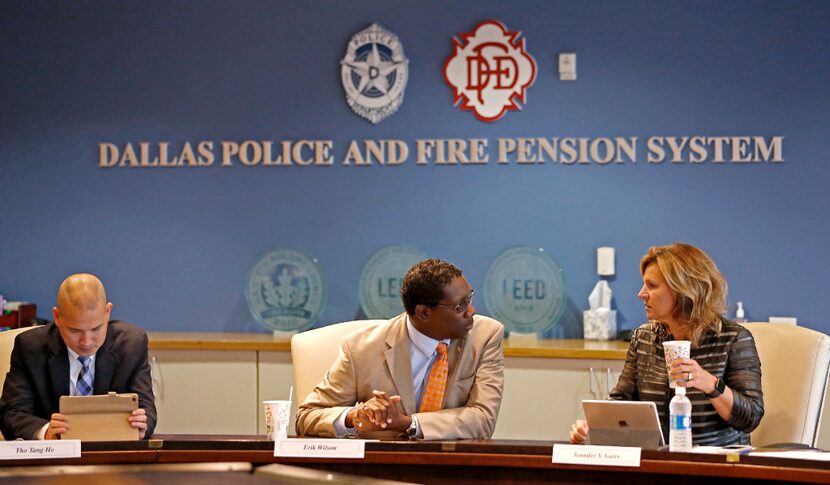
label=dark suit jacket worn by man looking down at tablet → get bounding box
[0,320,156,440]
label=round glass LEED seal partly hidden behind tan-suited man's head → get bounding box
[360,246,426,318]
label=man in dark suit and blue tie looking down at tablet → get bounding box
[0,274,156,440]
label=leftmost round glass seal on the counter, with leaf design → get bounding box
[245,249,326,332]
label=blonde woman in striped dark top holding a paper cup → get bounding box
[570,243,764,446]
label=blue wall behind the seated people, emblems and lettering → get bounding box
[0,0,830,336]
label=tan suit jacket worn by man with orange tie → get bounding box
[297,313,504,439]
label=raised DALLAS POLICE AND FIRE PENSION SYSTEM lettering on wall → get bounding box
[98,135,784,169]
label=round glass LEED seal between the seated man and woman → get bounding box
[484,246,567,333]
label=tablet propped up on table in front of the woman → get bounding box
[582,400,663,450]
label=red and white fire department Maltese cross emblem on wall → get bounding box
[444,20,536,122]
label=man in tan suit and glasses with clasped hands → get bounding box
[297,259,504,439]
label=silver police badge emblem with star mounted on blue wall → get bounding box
[340,24,409,123]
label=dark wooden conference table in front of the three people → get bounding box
[0,435,830,485]
